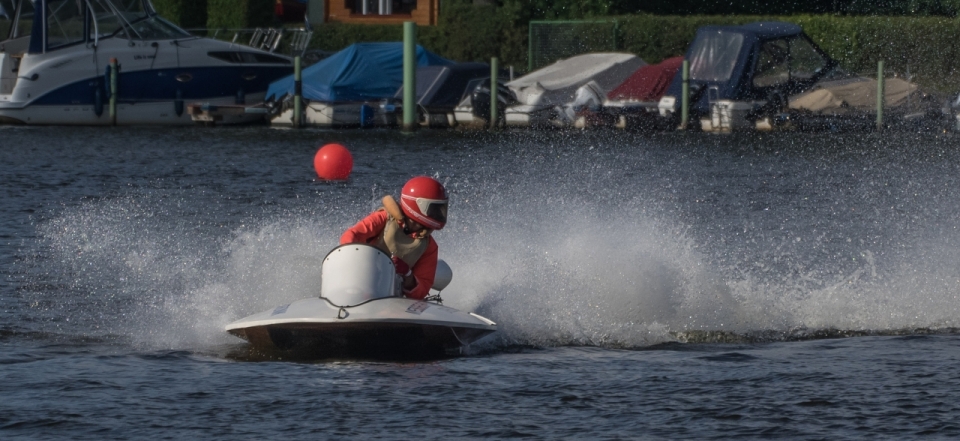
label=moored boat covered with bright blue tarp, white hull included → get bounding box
[266,42,453,126]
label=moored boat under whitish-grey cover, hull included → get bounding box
[505,53,646,126]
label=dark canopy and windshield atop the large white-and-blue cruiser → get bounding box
[0,0,190,54]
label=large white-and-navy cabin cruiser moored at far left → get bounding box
[0,0,293,125]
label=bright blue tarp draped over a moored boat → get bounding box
[264,42,453,102]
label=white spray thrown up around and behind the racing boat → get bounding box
[18,129,960,347]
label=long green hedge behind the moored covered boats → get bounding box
[312,10,960,91]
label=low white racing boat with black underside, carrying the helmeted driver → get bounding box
[226,244,497,359]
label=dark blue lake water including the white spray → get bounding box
[0,127,960,440]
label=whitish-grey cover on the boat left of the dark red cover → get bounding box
[507,53,647,107]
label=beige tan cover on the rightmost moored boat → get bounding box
[790,77,919,115]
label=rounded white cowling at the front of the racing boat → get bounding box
[320,244,400,306]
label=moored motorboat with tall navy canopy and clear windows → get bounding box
[657,22,837,132]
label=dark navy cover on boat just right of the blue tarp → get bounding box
[393,63,490,110]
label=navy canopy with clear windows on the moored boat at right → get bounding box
[667,22,836,113]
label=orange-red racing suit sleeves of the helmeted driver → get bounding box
[340,209,439,300]
